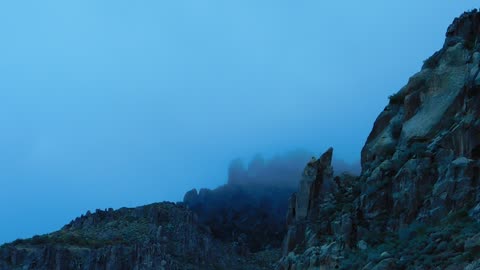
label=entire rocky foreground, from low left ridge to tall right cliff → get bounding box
[0,9,480,270]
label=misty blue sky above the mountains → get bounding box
[0,0,474,244]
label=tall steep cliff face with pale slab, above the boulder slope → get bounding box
[359,11,480,234]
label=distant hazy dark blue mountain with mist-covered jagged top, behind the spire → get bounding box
[183,150,318,253]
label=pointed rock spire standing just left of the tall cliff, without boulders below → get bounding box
[283,148,355,255]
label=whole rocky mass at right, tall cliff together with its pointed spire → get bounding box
[278,10,480,270]
